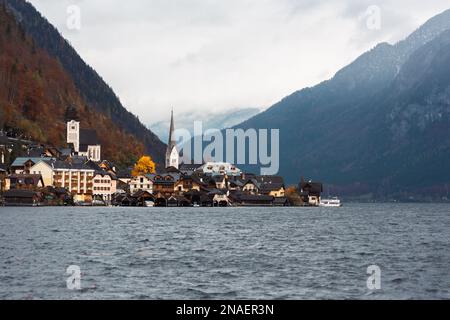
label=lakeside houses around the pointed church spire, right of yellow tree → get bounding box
[113,111,296,206]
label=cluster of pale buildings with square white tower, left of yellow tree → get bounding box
[1,120,117,204]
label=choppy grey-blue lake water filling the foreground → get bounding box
[0,204,450,299]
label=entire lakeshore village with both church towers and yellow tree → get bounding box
[0,112,323,207]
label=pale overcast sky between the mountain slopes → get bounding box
[30,0,450,124]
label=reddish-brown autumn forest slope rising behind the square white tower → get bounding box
[0,3,144,165]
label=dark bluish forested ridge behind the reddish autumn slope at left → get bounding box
[0,0,165,163]
